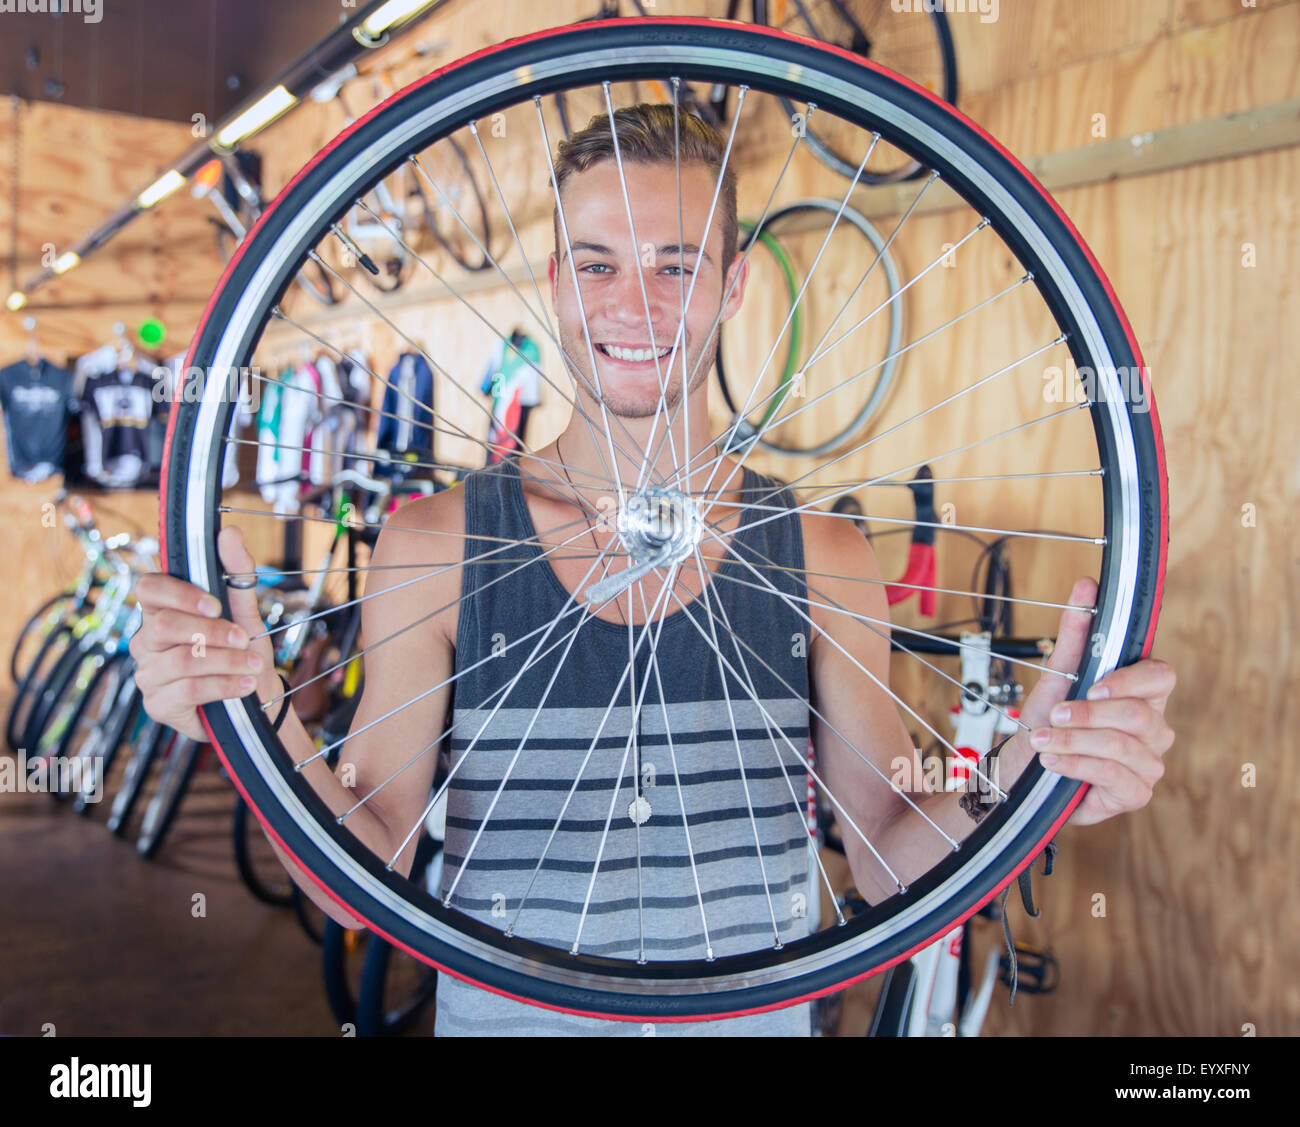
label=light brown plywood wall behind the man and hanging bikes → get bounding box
[0,0,1300,1036]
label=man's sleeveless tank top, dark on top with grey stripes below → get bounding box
[436,459,816,1036]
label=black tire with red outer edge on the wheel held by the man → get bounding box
[161,19,1169,1020]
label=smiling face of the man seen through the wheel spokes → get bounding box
[547,160,748,419]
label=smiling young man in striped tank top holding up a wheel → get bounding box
[131,105,1174,1036]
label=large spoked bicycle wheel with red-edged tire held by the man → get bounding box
[161,19,1167,1022]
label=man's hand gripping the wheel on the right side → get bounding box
[998,578,1175,825]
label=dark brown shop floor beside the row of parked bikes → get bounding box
[0,717,339,1037]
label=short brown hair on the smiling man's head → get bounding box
[554,101,740,277]
